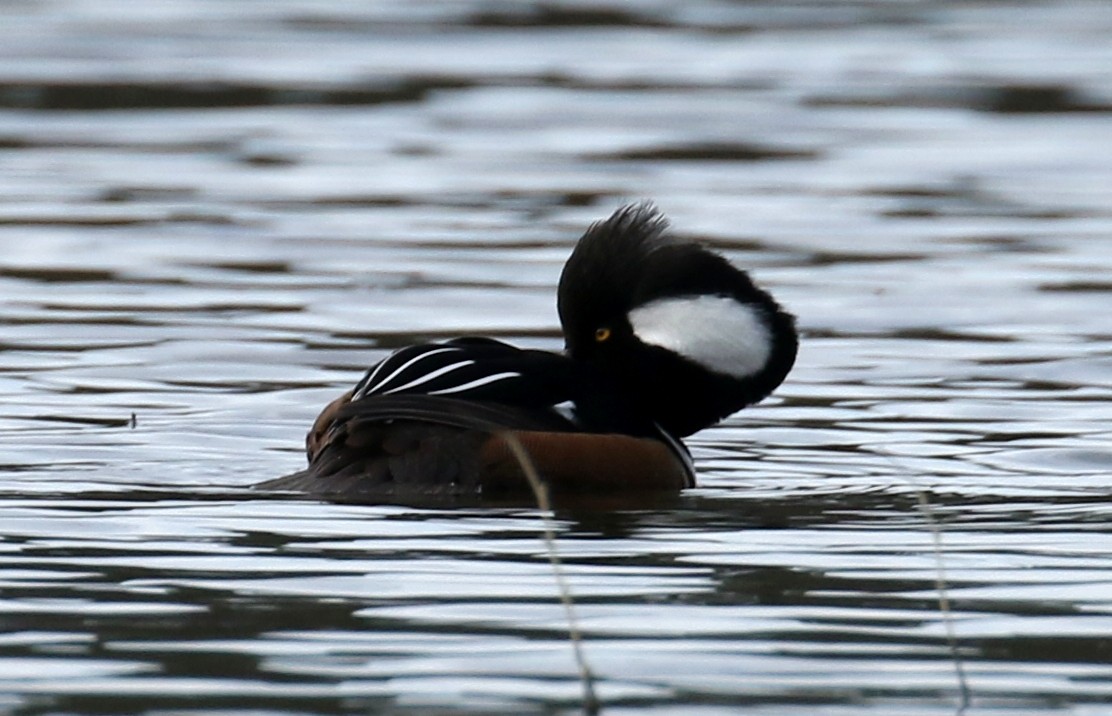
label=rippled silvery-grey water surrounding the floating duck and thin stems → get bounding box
[0,0,1112,716]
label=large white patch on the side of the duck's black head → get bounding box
[629,296,772,378]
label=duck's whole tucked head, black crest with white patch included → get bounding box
[557,203,797,436]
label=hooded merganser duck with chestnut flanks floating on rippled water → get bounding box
[262,203,797,499]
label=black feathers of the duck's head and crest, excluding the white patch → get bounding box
[557,202,797,436]
